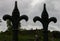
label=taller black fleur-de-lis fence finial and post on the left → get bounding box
[3,1,28,41]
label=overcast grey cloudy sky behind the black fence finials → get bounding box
[0,0,60,31]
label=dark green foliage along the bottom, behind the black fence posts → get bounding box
[0,30,60,41]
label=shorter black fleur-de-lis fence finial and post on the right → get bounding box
[33,4,57,41]
